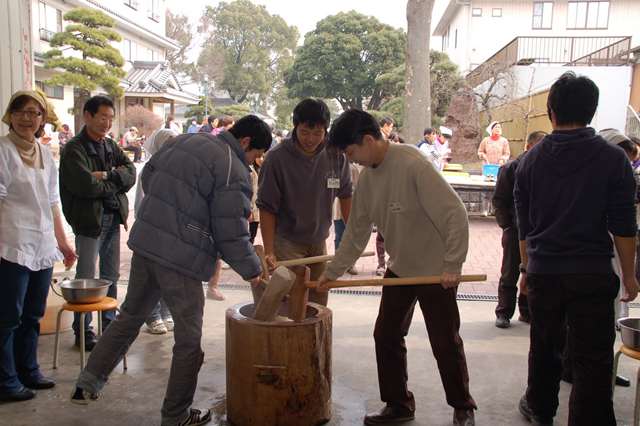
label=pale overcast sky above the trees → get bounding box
[165,0,449,60]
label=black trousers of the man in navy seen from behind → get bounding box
[526,274,619,426]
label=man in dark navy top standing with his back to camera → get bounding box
[513,72,638,426]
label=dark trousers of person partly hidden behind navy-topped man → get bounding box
[496,227,529,319]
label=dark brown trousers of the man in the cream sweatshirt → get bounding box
[374,269,477,410]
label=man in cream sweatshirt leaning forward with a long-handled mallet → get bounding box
[319,110,477,426]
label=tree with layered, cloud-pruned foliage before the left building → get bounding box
[44,8,125,131]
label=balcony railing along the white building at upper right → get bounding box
[466,37,631,87]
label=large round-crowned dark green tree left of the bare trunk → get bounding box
[286,11,406,109]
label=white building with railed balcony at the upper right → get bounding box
[434,0,640,154]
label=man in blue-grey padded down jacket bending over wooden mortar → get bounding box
[72,115,271,426]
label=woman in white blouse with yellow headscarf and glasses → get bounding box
[0,91,76,402]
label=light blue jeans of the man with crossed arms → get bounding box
[73,214,120,336]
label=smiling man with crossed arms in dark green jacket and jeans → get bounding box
[60,96,136,350]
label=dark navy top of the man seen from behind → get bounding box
[514,128,637,274]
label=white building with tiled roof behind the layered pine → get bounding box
[0,0,199,138]
